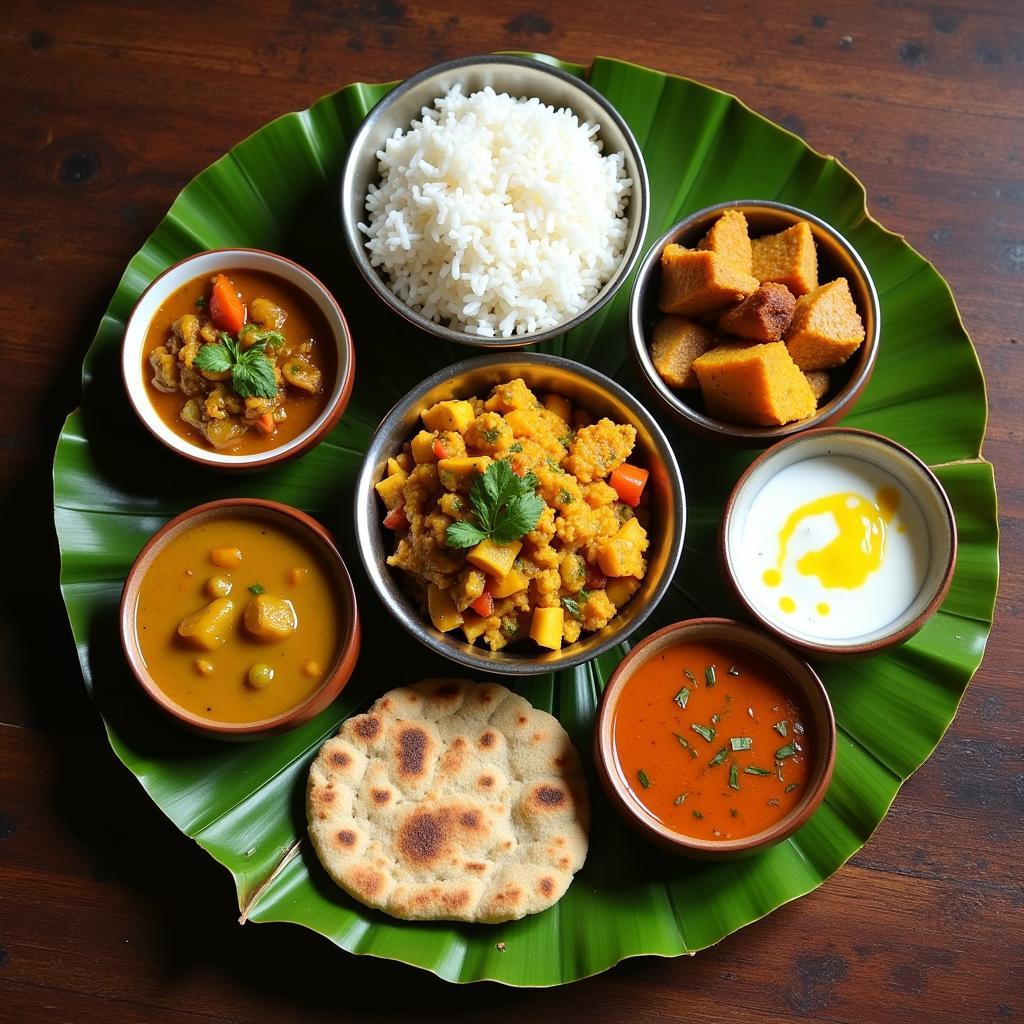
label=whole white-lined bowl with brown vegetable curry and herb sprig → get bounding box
[122,249,354,468]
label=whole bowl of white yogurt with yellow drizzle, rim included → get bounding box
[720,429,956,657]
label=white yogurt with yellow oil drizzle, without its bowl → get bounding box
[732,456,929,642]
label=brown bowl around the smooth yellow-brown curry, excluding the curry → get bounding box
[119,498,361,739]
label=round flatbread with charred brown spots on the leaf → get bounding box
[306,679,590,924]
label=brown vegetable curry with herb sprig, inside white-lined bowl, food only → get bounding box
[142,270,337,455]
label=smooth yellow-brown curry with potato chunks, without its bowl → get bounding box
[135,515,341,724]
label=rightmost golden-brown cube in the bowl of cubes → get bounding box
[785,278,864,370]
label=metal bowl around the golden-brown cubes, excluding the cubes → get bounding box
[629,199,882,449]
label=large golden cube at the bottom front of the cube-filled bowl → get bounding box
[693,341,817,427]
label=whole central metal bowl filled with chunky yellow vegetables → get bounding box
[356,353,685,674]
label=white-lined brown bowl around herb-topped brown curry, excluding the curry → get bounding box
[121,249,355,471]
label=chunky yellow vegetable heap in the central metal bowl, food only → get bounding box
[376,378,648,650]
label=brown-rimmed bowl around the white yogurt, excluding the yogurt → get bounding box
[719,427,956,658]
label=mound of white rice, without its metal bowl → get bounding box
[359,85,633,338]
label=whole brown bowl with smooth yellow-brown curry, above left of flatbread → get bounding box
[121,499,359,738]
